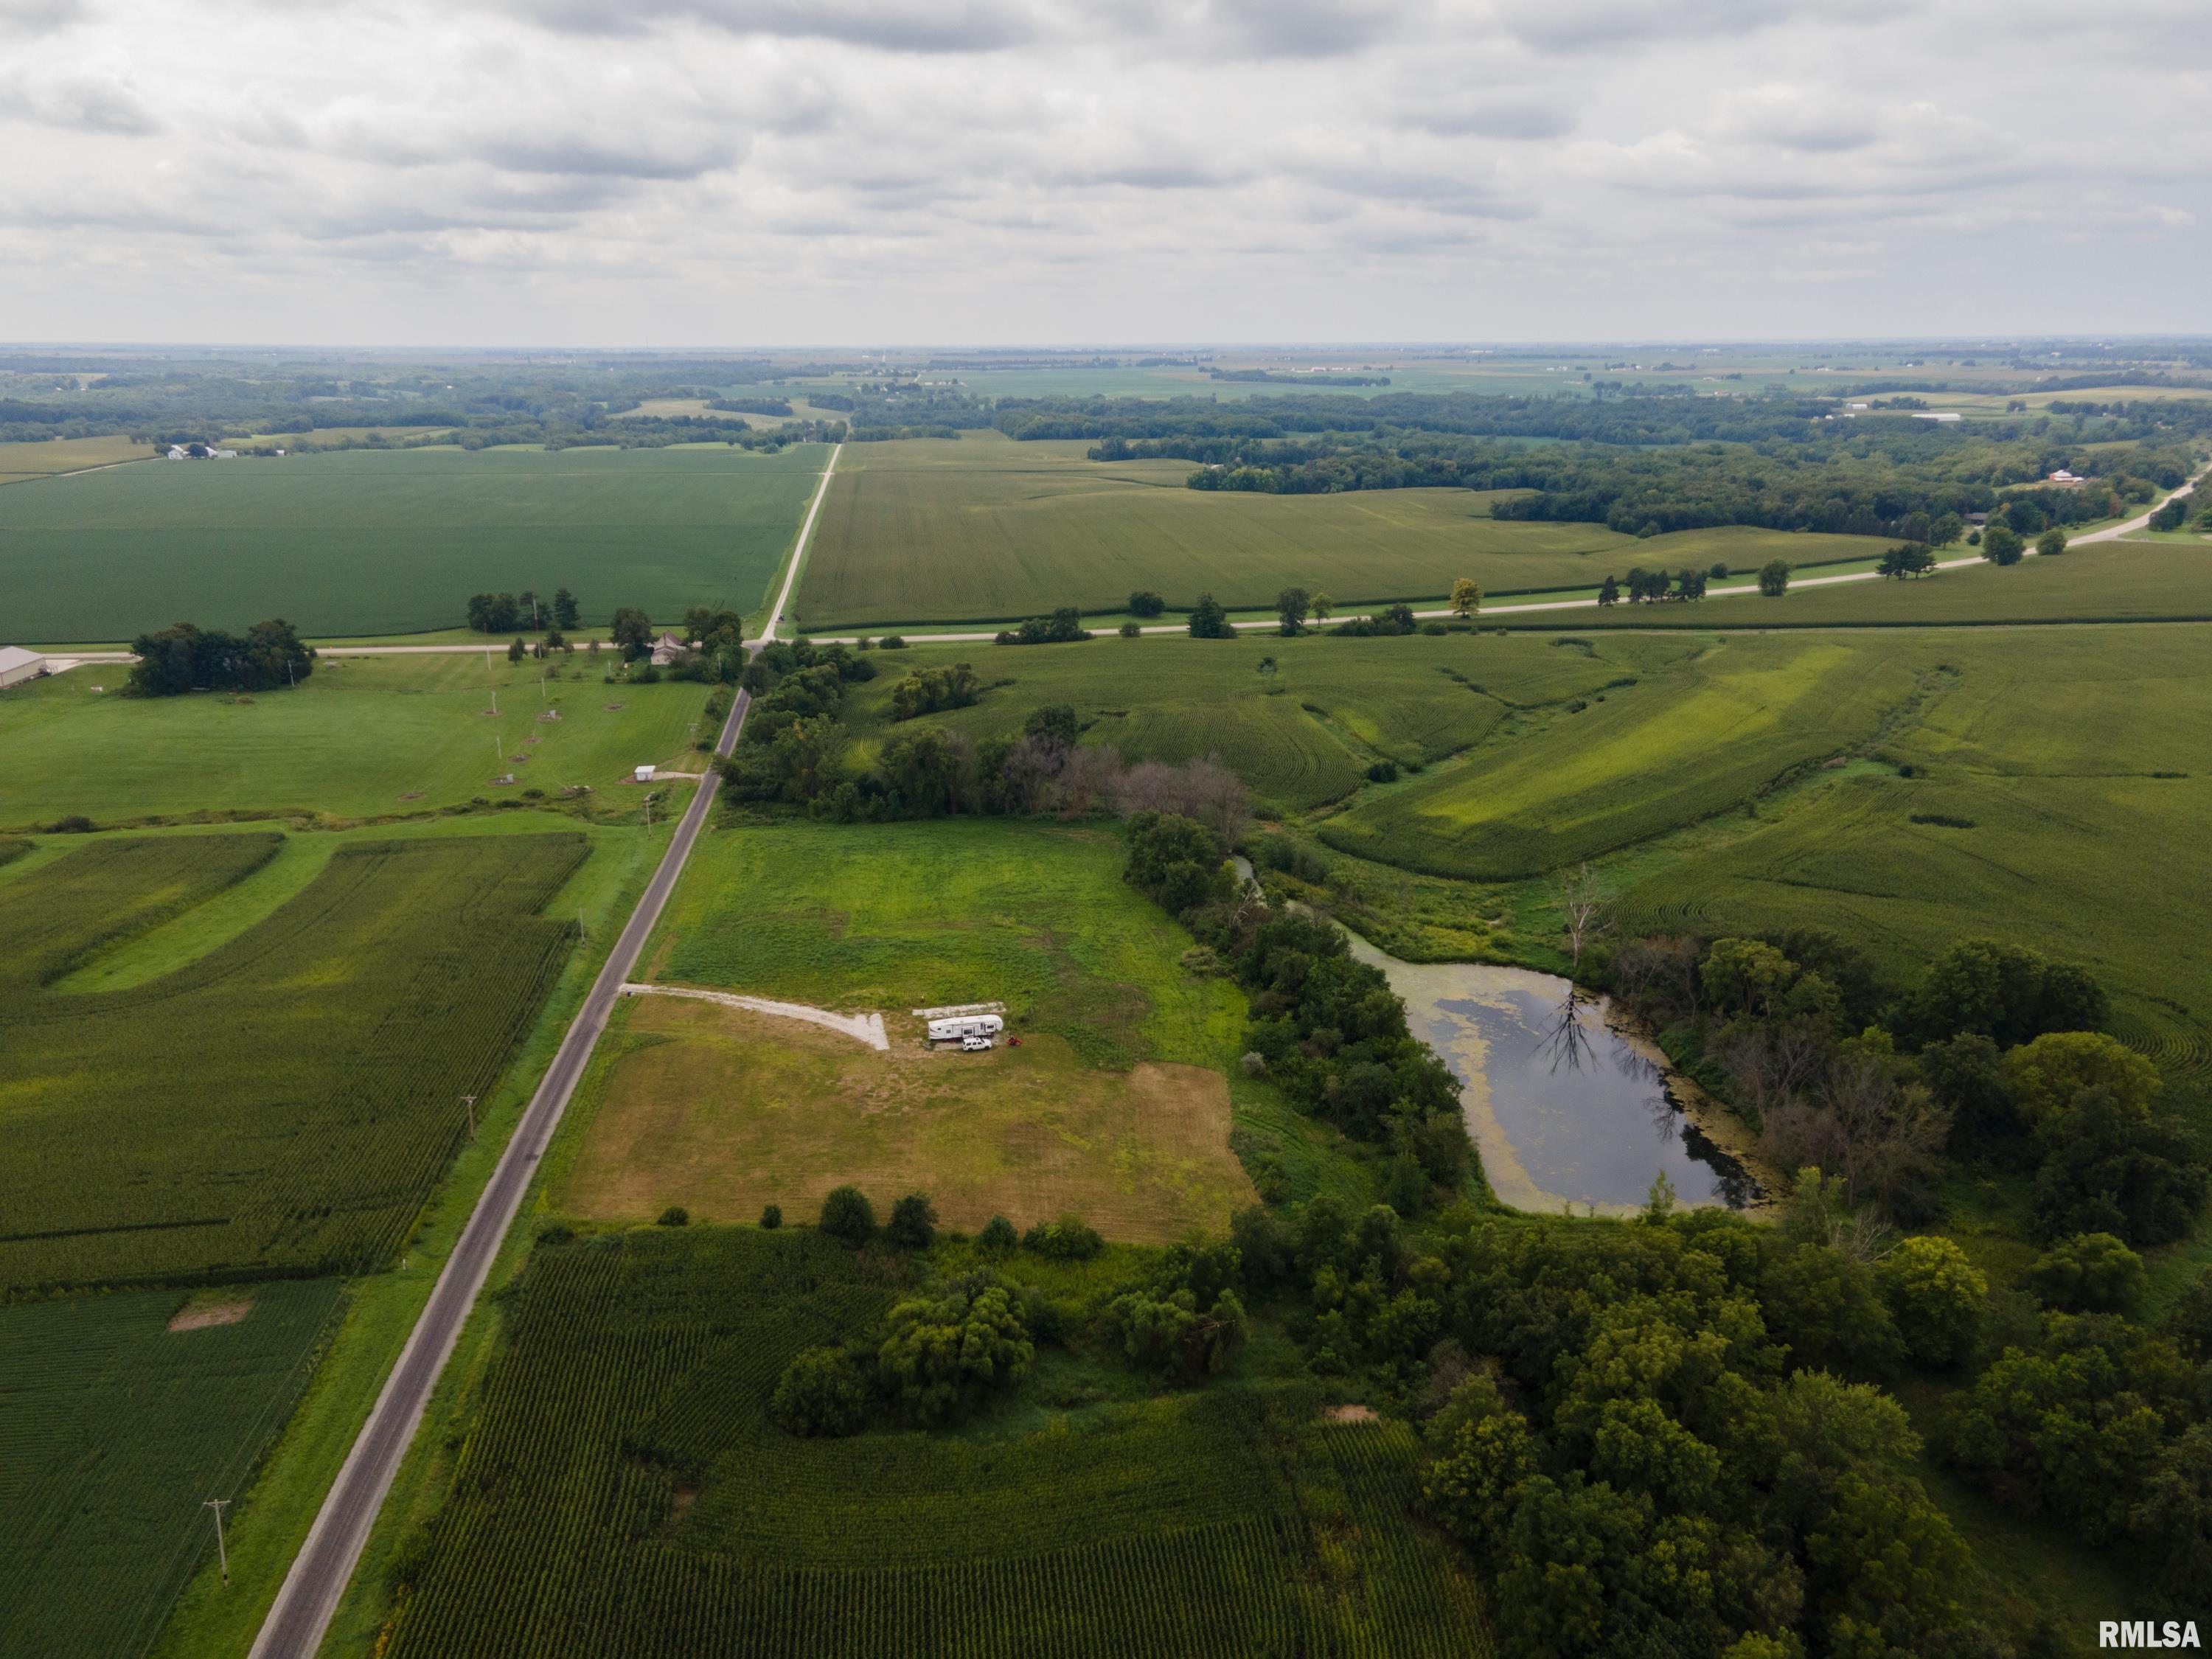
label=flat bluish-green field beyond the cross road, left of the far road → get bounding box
[0,445,827,644]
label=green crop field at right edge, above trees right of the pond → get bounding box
[1621,626,2212,1084]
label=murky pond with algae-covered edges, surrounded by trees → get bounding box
[1347,933,1761,1214]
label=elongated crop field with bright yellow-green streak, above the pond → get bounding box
[1321,635,1916,880]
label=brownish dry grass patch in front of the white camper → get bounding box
[553,998,1256,1241]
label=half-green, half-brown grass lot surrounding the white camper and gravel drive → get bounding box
[606,821,1292,1241]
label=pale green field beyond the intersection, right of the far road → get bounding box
[799,431,1880,633]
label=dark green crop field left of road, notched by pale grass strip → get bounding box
[0,832,586,1290]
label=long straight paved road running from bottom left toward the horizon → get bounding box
[252,445,843,1659]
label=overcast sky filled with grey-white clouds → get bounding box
[0,0,2212,345]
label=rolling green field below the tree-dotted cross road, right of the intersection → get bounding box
[849,633,1694,812]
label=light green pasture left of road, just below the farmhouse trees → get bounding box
[0,653,708,830]
